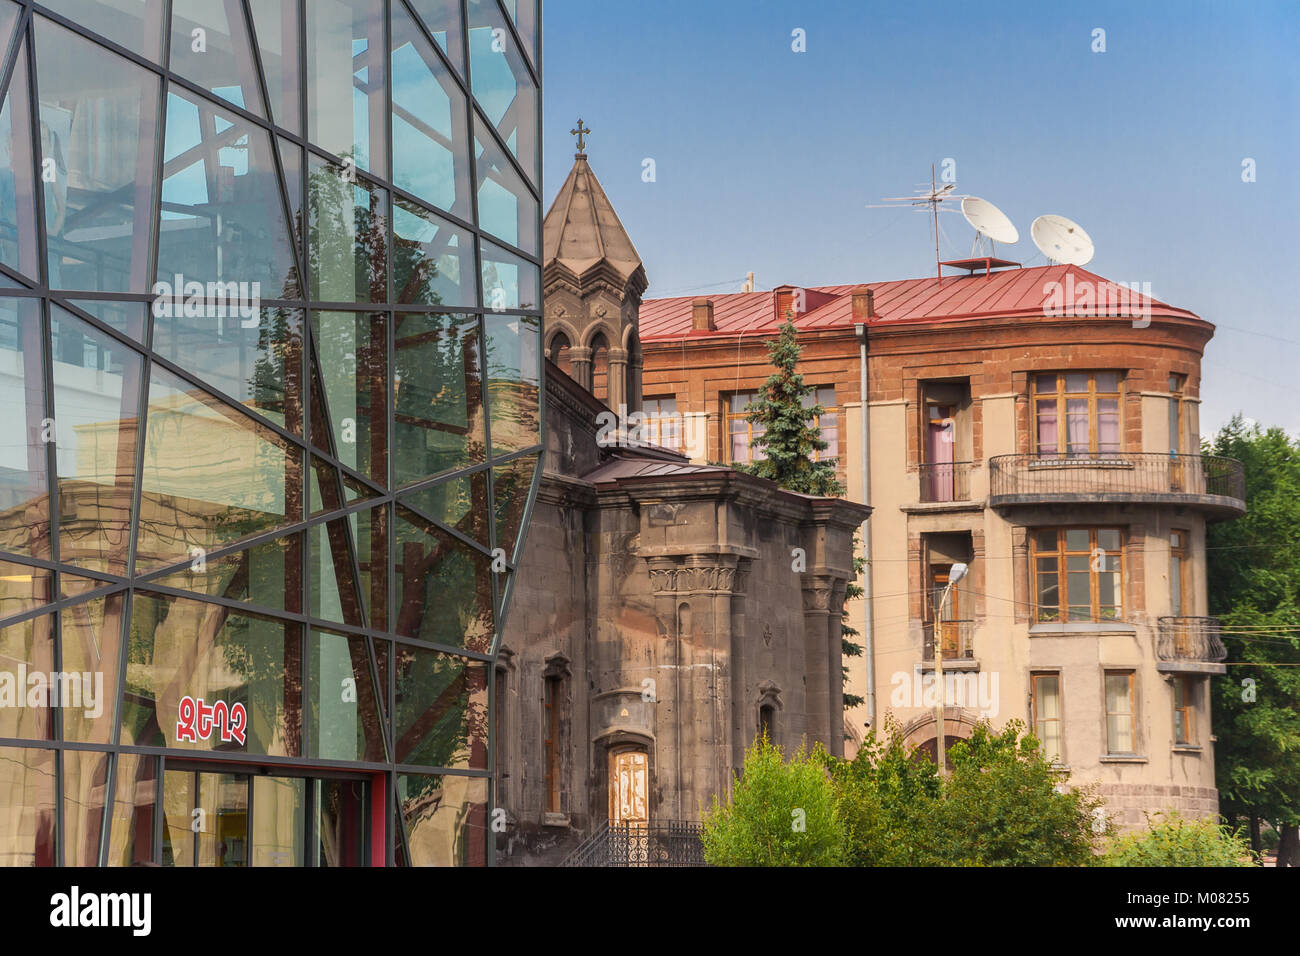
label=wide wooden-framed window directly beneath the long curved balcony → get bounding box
[1031,528,1123,622]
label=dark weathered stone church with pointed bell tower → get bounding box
[494,138,870,865]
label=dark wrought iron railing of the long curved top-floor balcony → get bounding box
[988,453,1245,501]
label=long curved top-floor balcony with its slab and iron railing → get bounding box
[988,453,1245,519]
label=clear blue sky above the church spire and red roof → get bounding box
[543,0,1300,433]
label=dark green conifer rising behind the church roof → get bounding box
[735,312,844,497]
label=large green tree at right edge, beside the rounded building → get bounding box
[1205,416,1300,866]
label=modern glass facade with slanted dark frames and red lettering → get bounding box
[0,0,542,866]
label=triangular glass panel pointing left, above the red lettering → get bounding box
[146,535,303,614]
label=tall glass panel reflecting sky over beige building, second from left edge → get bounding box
[49,304,144,575]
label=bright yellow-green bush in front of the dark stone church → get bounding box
[703,736,846,866]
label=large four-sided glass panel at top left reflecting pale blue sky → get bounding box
[35,17,160,293]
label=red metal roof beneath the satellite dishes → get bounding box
[640,265,1200,342]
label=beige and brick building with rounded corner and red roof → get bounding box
[629,261,1245,826]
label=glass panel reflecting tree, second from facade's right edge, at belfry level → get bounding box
[393,313,486,486]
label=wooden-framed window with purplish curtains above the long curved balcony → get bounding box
[1034,372,1119,458]
